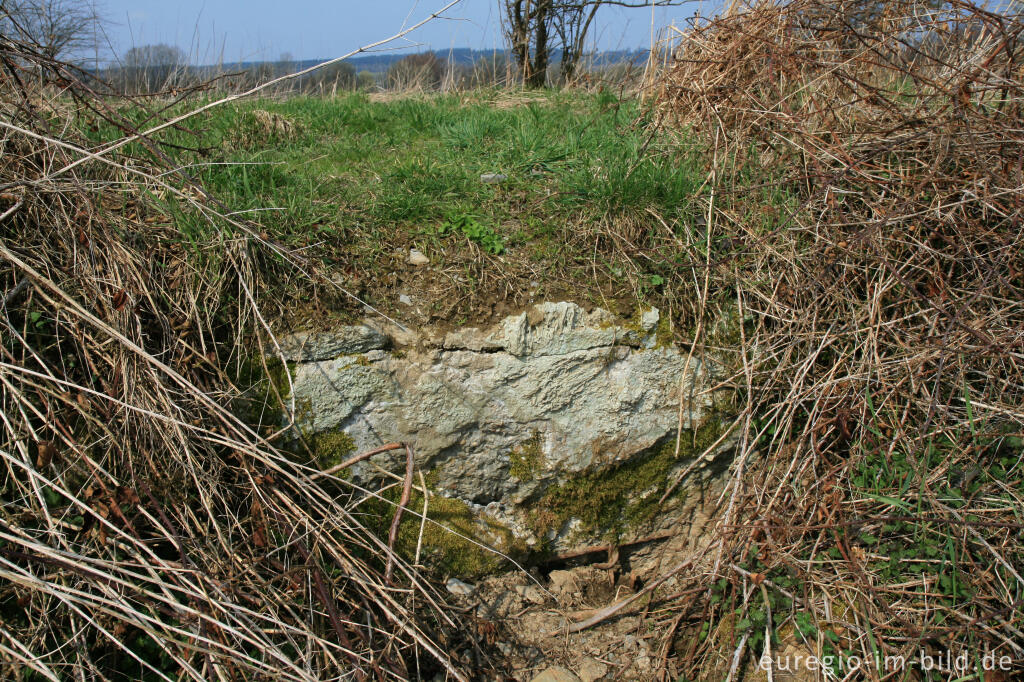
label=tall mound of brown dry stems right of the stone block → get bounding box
[653,0,1024,679]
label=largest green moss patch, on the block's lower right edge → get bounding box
[530,417,726,542]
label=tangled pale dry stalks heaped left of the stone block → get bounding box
[0,3,489,680]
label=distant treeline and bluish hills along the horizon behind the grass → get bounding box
[96,45,647,94]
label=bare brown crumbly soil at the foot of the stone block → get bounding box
[451,512,712,682]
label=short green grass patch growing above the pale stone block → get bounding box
[93,91,703,327]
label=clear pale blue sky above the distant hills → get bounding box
[97,0,710,63]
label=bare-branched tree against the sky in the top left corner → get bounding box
[0,0,99,59]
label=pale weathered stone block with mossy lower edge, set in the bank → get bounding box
[276,302,731,550]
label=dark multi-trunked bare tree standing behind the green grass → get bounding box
[502,0,685,88]
